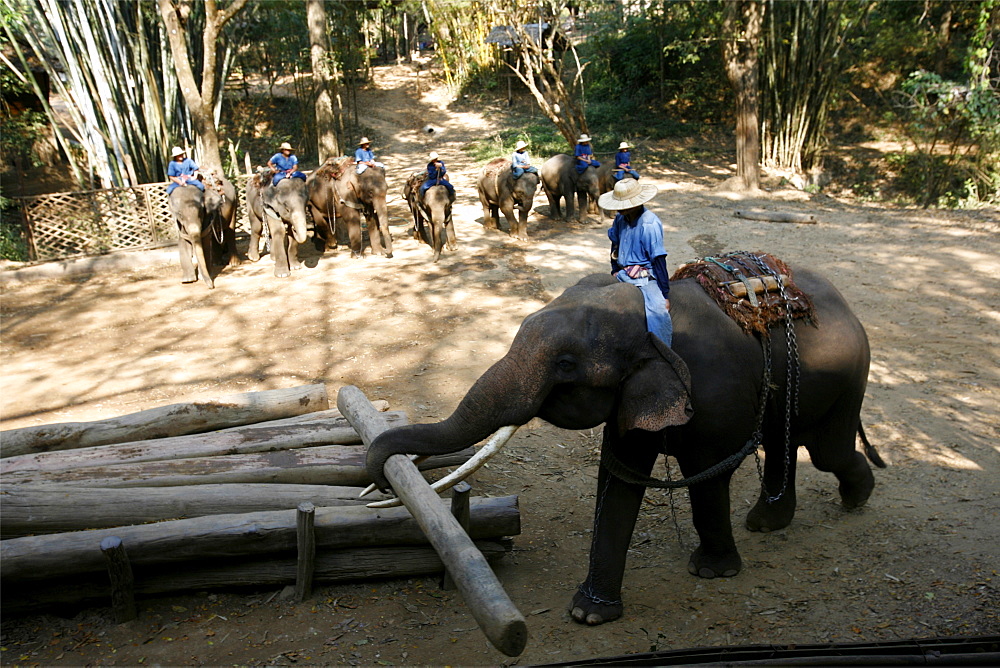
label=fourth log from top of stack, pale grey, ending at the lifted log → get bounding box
[0,483,398,539]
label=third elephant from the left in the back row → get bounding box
[307,157,392,258]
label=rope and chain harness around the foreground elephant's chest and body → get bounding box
[601,251,800,503]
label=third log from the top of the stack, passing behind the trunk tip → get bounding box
[0,445,475,487]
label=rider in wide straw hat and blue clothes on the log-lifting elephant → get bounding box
[598,179,674,346]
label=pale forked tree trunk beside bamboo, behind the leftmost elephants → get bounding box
[159,0,247,174]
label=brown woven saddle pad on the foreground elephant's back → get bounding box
[670,251,815,336]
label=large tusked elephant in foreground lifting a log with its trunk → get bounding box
[366,268,885,625]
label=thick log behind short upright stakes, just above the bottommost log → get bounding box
[0,496,521,586]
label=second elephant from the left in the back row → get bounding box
[247,174,309,278]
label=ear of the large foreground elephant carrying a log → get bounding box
[618,332,694,433]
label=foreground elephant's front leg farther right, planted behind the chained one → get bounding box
[681,462,743,578]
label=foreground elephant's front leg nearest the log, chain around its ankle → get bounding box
[570,427,659,626]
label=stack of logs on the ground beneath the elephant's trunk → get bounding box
[0,385,520,619]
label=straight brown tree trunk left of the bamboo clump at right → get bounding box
[722,0,764,190]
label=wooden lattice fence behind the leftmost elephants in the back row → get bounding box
[13,176,250,261]
